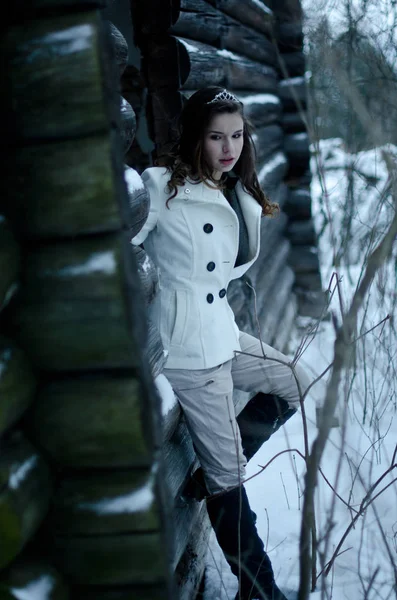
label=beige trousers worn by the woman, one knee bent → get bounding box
[164,333,310,494]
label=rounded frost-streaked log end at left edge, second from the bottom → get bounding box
[0,432,51,569]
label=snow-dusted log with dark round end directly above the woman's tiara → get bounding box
[145,36,277,93]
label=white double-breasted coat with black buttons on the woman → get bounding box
[132,167,262,369]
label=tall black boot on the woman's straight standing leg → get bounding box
[207,486,287,600]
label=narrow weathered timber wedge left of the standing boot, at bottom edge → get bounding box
[175,503,211,600]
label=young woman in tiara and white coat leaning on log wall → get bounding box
[133,87,307,600]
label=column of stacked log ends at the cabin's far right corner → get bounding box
[274,0,325,318]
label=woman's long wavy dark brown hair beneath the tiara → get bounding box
[156,86,278,216]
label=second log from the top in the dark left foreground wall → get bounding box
[4,134,120,238]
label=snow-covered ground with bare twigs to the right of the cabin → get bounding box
[205,140,397,600]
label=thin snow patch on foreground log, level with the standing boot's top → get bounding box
[78,476,154,515]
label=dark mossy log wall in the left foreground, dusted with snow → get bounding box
[0,0,173,600]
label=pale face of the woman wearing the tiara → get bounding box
[203,112,244,179]
